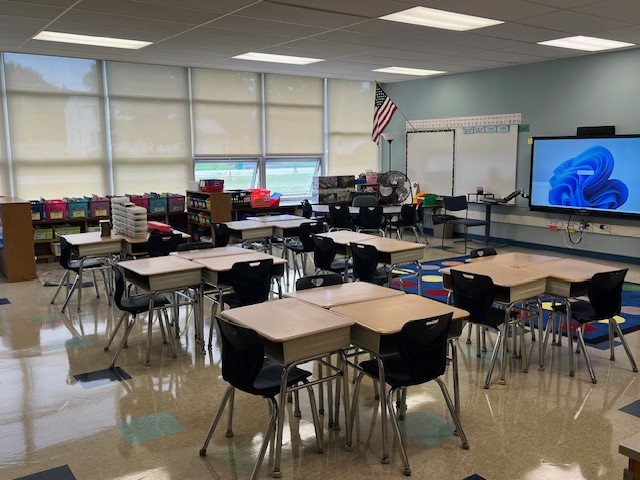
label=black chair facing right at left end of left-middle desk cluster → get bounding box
[104,265,176,368]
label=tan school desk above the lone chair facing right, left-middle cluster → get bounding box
[118,255,204,365]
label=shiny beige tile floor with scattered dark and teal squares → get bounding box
[0,247,640,480]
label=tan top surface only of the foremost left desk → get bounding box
[222,298,353,346]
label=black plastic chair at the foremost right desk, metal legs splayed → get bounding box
[350,313,469,476]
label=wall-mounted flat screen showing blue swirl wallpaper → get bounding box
[529,135,640,217]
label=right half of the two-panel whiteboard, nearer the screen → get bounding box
[452,125,518,198]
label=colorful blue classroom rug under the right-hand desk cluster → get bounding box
[392,257,640,344]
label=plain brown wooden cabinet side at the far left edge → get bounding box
[0,197,36,282]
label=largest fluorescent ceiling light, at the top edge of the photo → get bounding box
[380,7,504,32]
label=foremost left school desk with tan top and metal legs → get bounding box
[222,298,353,478]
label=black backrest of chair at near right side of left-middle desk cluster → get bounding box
[231,258,273,306]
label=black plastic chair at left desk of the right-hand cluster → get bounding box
[451,270,528,388]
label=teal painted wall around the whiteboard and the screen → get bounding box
[384,49,640,258]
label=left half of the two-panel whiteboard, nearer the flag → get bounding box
[407,130,455,195]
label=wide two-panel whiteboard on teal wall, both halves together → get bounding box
[407,125,518,197]
